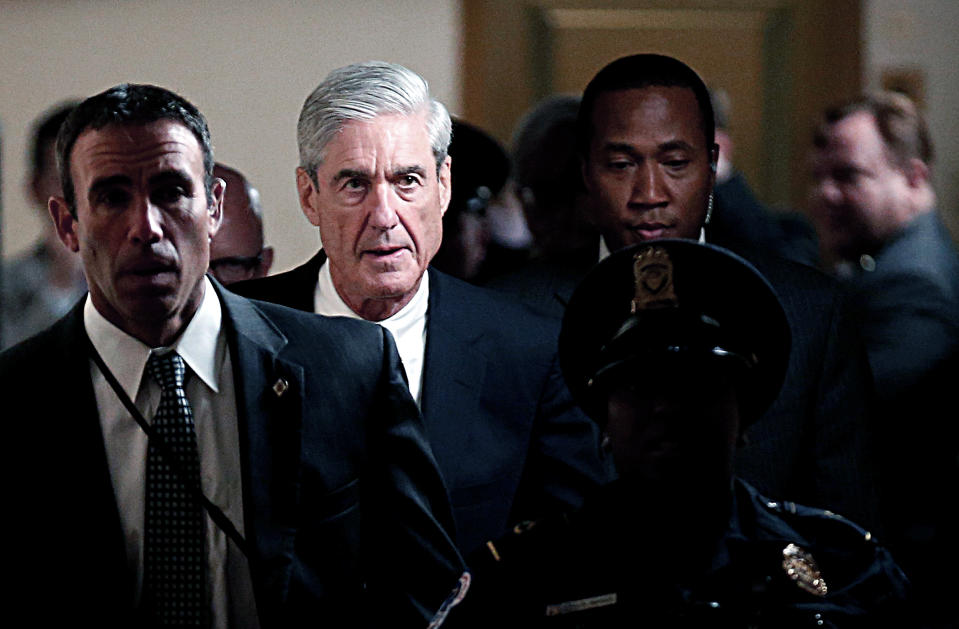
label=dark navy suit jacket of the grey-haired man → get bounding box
[230,251,609,554]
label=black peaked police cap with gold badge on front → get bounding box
[559,240,790,426]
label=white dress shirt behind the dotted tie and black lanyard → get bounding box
[83,278,258,629]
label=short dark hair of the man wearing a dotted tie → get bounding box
[57,83,214,216]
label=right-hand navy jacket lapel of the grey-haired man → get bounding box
[421,269,487,474]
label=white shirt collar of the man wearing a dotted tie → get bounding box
[83,277,226,399]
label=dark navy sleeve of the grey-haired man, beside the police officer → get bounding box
[511,352,614,522]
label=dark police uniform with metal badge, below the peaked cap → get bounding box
[457,479,914,629]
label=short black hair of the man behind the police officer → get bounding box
[576,54,716,159]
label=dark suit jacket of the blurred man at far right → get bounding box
[847,212,959,626]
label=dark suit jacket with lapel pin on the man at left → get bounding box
[0,285,462,627]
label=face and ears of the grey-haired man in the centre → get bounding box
[297,114,450,321]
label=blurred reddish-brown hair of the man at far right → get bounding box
[813,92,935,168]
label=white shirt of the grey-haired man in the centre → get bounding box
[313,261,430,404]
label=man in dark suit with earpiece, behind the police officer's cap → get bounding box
[496,54,877,527]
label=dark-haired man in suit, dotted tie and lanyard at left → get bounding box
[0,85,468,627]
